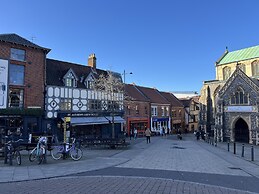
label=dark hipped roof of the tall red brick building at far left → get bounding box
[0,34,50,53]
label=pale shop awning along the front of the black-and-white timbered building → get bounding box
[70,116,125,125]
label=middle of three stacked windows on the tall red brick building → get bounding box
[9,64,24,85]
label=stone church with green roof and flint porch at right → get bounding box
[199,46,259,144]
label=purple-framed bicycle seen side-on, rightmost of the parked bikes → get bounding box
[51,138,83,161]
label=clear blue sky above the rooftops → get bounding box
[0,0,259,92]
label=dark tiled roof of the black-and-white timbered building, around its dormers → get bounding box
[46,59,107,88]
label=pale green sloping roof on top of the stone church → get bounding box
[217,46,259,65]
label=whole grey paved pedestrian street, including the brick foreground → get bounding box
[0,135,259,194]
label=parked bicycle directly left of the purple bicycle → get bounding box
[29,137,47,164]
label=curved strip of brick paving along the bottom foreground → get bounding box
[0,176,256,194]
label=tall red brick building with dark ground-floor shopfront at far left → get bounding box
[0,34,50,146]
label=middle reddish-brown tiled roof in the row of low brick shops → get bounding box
[135,86,170,104]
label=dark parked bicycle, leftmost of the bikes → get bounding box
[5,137,23,165]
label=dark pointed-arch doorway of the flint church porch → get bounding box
[234,118,249,143]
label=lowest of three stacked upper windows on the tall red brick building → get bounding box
[9,88,23,108]
